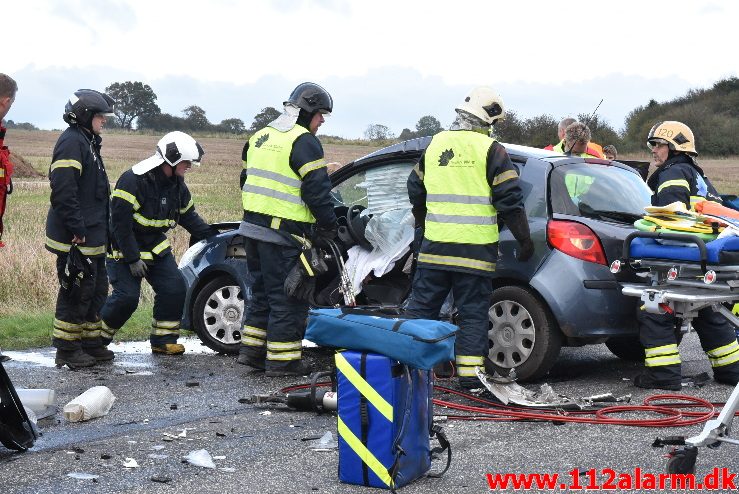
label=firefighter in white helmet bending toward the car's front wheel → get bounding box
[101,132,218,355]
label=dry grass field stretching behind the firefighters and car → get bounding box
[0,129,739,348]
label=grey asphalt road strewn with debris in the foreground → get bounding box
[0,334,739,494]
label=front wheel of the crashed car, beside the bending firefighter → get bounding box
[192,275,244,354]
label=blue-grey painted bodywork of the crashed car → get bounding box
[182,137,648,341]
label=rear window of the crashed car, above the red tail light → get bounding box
[549,163,652,223]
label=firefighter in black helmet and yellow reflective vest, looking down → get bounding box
[238,82,337,377]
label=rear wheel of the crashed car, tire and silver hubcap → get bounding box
[485,286,562,382]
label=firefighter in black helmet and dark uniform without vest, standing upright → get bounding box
[46,89,114,368]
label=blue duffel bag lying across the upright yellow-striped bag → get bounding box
[305,307,459,370]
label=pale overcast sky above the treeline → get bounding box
[5,0,739,137]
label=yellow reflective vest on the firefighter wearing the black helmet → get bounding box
[241,125,314,223]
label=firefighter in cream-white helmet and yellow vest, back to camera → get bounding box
[407,87,534,388]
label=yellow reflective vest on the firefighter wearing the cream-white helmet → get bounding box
[423,131,498,245]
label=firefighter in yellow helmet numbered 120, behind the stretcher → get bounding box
[634,121,739,391]
